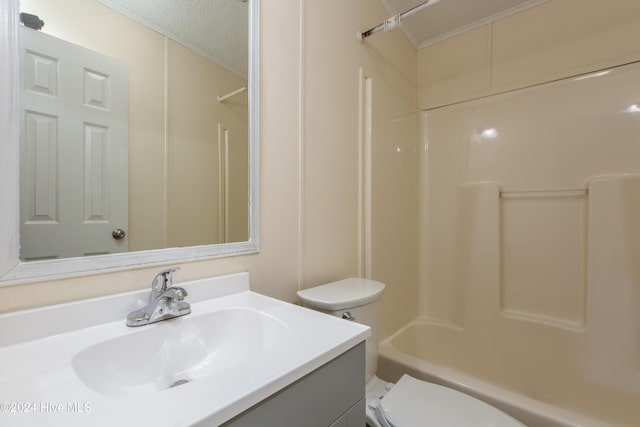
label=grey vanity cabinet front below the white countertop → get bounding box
[218,342,365,427]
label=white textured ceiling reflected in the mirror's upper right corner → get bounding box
[98,0,249,78]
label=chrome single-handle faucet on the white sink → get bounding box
[127,267,191,326]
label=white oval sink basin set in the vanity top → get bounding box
[72,307,288,395]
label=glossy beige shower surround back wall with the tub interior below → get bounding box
[418,64,640,426]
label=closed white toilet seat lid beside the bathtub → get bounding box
[372,374,525,427]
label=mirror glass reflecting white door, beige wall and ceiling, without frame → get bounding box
[21,0,251,260]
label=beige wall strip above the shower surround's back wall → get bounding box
[418,0,640,109]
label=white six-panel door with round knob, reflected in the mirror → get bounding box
[20,27,128,259]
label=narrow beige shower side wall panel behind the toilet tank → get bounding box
[372,112,420,337]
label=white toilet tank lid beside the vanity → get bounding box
[298,277,384,310]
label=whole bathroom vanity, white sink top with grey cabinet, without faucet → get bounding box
[0,273,370,427]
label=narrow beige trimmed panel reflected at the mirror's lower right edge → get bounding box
[222,125,249,242]
